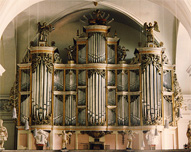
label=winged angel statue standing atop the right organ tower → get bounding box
[144,21,160,42]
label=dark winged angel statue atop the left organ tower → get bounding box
[38,22,54,42]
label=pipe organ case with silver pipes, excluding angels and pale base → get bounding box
[13,9,181,150]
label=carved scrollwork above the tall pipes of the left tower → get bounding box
[32,53,53,73]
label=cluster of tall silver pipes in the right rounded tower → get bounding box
[142,63,162,124]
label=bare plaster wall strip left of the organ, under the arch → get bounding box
[0,22,17,95]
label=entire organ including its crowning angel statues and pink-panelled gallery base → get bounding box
[9,10,182,150]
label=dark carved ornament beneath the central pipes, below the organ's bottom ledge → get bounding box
[81,131,112,139]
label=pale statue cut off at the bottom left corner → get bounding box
[0,119,8,150]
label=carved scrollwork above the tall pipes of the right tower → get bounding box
[141,54,162,73]
